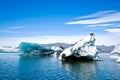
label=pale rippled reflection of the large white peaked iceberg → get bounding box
[62,61,97,80]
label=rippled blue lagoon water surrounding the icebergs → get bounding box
[0,53,120,80]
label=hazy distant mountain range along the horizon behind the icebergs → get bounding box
[0,43,115,53]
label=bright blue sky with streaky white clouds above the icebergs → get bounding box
[0,0,120,46]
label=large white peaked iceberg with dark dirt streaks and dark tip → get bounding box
[59,33,101,60]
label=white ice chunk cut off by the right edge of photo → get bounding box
[110,44,120,62]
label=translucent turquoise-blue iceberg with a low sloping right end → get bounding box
[19,42,54,56]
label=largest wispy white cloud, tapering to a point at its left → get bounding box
[65,10,120,26]
